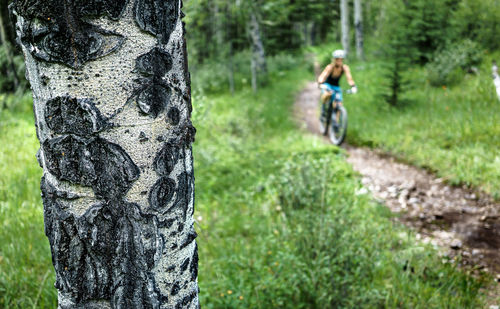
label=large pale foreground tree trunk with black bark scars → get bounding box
[13,0,199,309]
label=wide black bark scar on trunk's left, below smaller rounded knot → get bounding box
[42,135,140,201]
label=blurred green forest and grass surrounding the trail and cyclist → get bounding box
[0,0,500,308]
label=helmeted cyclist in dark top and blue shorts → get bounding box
[318,49,358,124]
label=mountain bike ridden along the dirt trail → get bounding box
[319,85,352,146]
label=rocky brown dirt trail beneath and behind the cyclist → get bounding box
[295,83,500,276]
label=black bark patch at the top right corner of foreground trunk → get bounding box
[134,0,179,44]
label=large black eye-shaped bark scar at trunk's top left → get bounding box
[13,0,127,69]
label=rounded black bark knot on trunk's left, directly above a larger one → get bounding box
[45,97,107,135]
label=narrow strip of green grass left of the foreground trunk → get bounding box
[0,94,56,308]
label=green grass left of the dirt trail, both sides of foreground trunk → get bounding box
[0,64,489,308]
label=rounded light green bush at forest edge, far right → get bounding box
[427,40,483,87]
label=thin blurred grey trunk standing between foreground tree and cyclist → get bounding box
[249,12,267,92]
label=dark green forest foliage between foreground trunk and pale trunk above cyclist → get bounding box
[185,0,338,64]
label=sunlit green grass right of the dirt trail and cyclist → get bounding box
[346,53,500,198]
